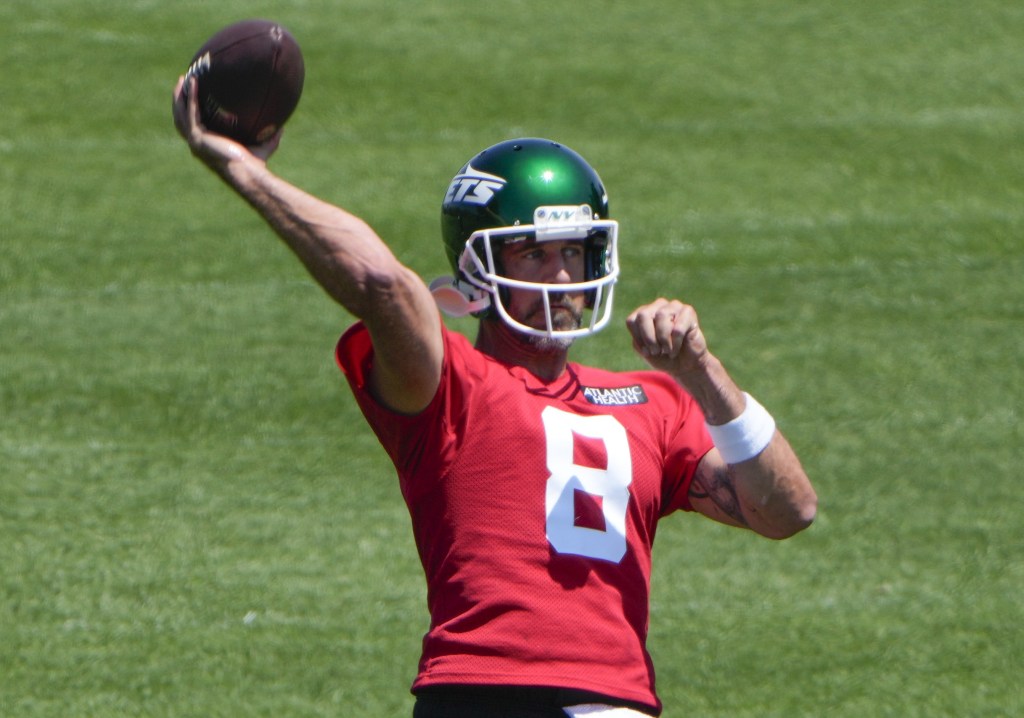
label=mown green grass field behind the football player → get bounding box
[0,0,1024,718]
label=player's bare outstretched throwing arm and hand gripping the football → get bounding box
[173,78,443,413]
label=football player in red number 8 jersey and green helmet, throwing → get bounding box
[174,75,816,718]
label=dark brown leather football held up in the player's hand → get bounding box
[185,19,305,145]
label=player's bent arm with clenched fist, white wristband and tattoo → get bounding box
[627,299,817,539]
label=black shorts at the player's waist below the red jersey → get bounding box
[413,685,657,718]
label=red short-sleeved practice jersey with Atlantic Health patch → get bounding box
[337,324,713,710]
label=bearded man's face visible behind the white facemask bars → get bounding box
[500,240,585,331]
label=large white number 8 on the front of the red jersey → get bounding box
[541,407,633,563]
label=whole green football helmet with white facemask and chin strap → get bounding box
[430,138,618,338]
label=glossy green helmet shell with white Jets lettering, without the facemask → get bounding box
[441,137,608,277]
